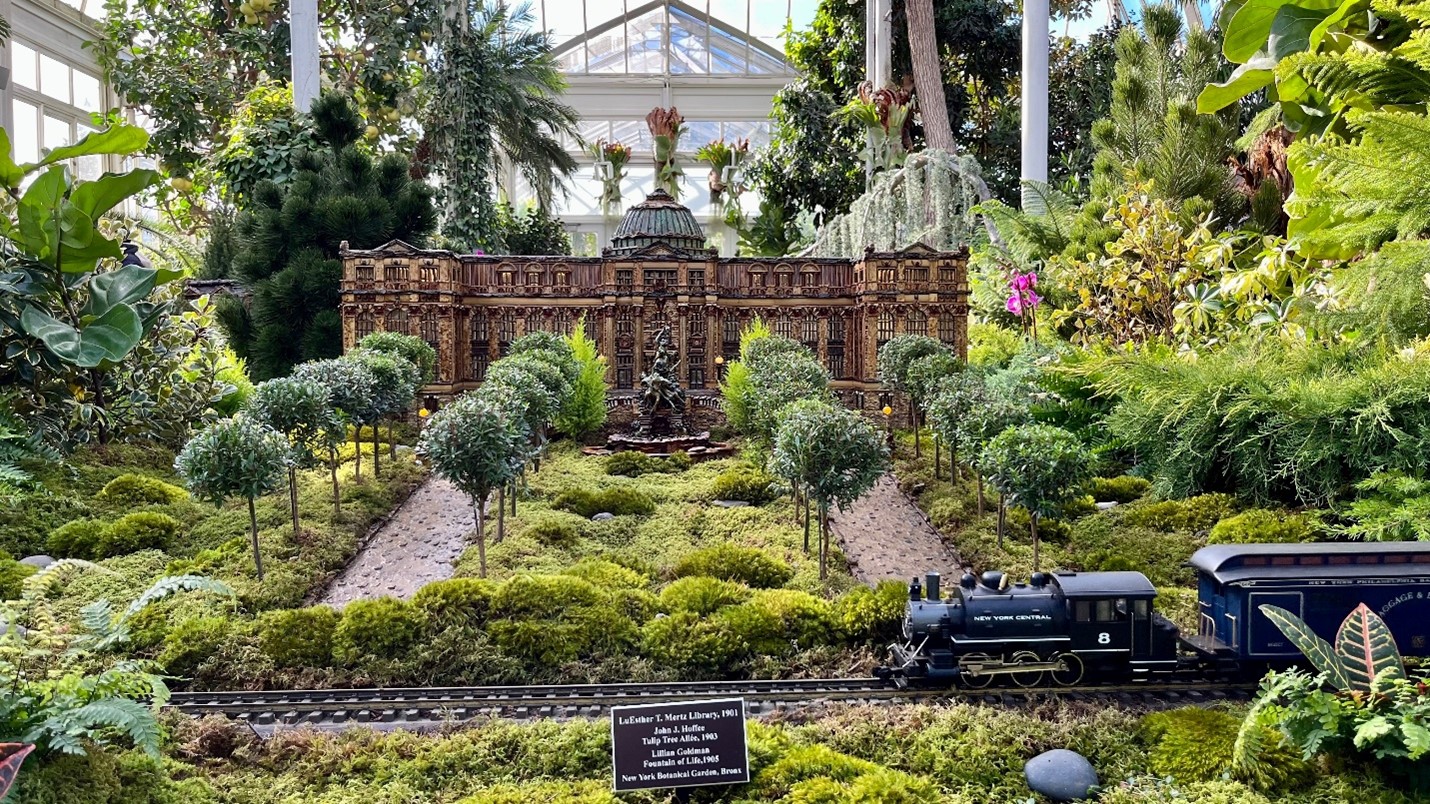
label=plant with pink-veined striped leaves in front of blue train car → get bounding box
[1233,604,1430,781]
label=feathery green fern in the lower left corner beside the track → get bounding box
[0,559,233,755]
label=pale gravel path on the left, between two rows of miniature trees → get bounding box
[319,478,476,608]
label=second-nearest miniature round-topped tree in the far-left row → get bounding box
[247,376,343,536]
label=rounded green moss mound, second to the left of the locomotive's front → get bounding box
[715,589,839,657]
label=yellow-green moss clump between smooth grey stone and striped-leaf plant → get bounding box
[1141,707,1241,783]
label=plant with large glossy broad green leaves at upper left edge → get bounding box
[0,123,167,442]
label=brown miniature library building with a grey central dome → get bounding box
[342,190,968,408]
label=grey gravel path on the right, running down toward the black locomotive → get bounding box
[829,475,961,584]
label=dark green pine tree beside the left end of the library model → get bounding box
[220,93,436,379]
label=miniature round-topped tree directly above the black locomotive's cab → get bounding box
[984,423,1093,571]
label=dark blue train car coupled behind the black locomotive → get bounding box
[1183,542,1430,668]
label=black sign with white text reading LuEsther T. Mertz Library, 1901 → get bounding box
[611,698,749,793]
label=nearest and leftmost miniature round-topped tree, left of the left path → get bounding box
[174,415,290,581]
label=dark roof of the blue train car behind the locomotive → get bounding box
[1188,542,1430,584]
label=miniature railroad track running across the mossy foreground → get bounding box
[169,678,1256,732]
